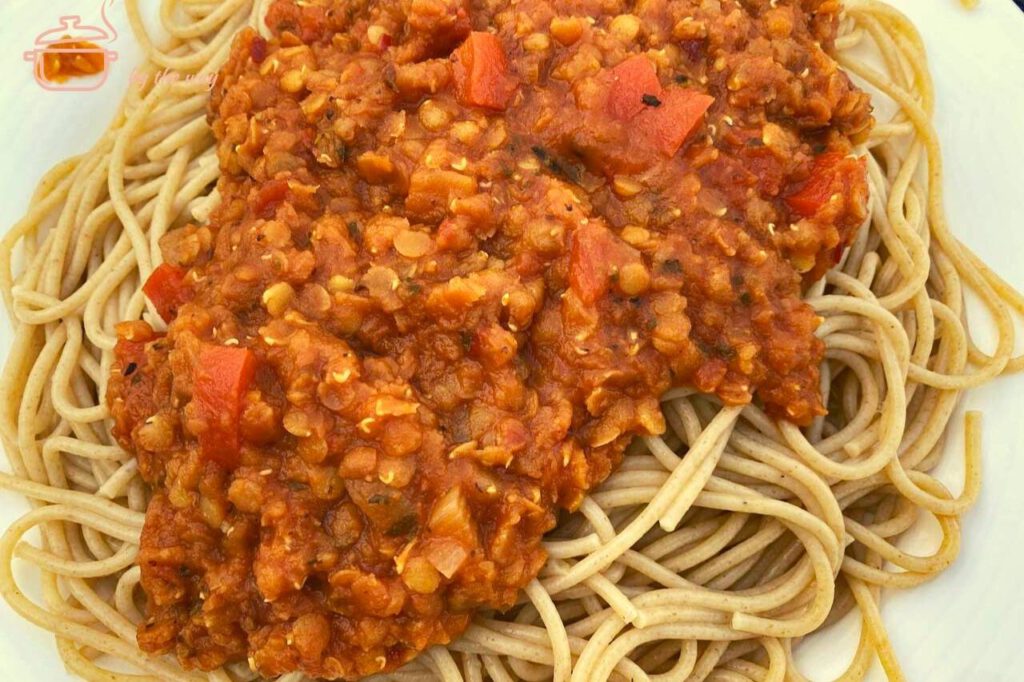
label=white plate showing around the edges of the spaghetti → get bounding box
[0,0,1024,682]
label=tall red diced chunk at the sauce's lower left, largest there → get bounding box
[193,344,256,469]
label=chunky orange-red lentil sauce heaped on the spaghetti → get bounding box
[108,0,871,679]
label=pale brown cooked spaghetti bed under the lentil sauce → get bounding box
[0,0,1024,682]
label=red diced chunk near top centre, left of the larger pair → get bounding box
[452,31,515,110]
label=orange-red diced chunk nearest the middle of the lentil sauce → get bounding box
[569,223,640,304]
